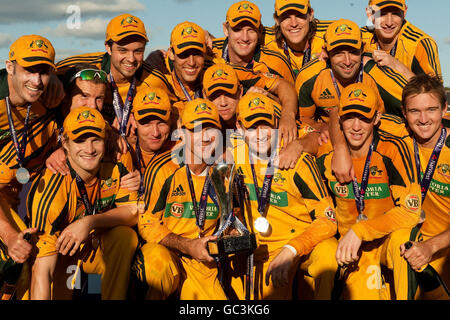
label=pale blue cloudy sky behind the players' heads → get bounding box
[0,0,450,87]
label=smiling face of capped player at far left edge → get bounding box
[6,60,52,105]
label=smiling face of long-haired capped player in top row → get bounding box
[275,10,314,50]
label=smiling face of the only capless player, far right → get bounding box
[403,93,447,148]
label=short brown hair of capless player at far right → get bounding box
[402,73,447,111]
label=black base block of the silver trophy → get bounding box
[207,233,257,257]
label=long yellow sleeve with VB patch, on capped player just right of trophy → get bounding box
[288,154,337,255]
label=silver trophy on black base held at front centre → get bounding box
[208,162,256,257]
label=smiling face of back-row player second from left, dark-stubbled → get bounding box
[105,36,146,83]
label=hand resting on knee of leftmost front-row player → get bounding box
[56,216,91,256]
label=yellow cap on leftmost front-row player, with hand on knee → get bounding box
[63,107,106,140]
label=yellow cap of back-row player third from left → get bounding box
[170,21,206,54]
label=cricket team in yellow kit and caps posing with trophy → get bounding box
[0,0,450,300]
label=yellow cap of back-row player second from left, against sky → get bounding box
[106,13,148,42]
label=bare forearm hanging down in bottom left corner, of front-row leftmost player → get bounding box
[30,254,58,300]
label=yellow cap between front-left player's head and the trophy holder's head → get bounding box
[133,87,172,122]
